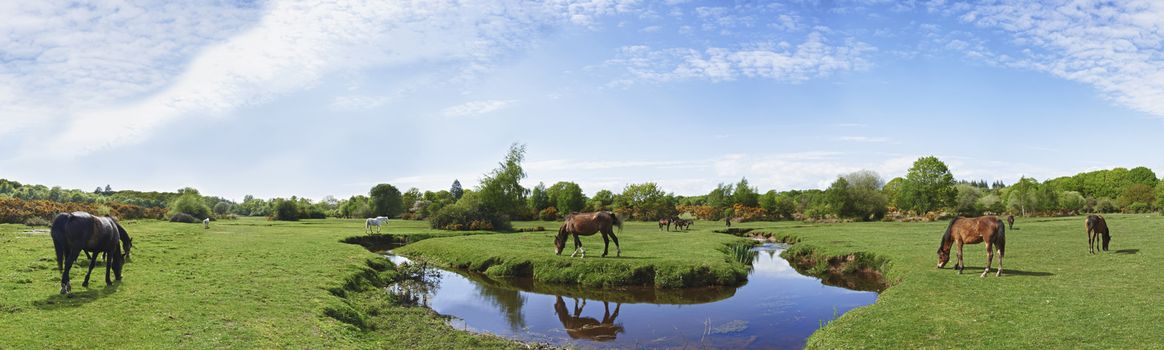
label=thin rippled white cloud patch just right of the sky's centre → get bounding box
[606,31,873,85]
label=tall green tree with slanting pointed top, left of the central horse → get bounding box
[477,143,526,215]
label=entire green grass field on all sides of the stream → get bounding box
[0,215,1164,349]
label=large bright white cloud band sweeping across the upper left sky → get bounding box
[0,0,633,155]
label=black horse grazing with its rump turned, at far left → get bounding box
[50,212,132,294]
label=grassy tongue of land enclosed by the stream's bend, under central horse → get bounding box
[396,222,747,288]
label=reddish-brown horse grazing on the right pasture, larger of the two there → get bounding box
[938,216,1007,277]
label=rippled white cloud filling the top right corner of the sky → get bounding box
[951,0,1164,117]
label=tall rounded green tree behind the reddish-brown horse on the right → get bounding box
[896,156,957,213]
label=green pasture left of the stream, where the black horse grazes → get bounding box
[0,219,520,349]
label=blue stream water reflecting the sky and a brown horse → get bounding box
[388,244,876,349]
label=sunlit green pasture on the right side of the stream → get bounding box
[726,215,1164,349]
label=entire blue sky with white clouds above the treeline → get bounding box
[0,0,1164,199]
